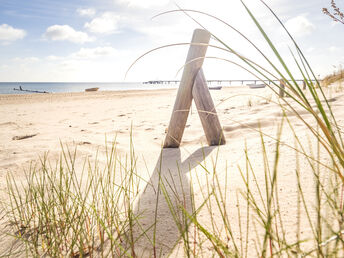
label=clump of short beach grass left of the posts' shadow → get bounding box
[5,140,148,257]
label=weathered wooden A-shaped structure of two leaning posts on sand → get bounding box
[164,29,226,148]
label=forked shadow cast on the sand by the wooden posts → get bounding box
[135,147,216,257]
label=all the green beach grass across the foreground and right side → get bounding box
[5,3,344,257]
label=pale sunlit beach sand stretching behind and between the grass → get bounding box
[0,86,344,257]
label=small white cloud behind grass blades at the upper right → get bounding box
[285,16,315,37]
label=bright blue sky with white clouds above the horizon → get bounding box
[0,0,344,82]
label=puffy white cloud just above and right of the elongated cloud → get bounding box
[85,12,120,34]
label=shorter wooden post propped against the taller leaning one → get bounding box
[192,68,226,146]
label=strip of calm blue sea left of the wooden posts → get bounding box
[0,82,178,94]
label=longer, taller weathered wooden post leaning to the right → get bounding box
[164,29,210,148]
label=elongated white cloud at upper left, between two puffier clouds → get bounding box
[44,25,94,44]
